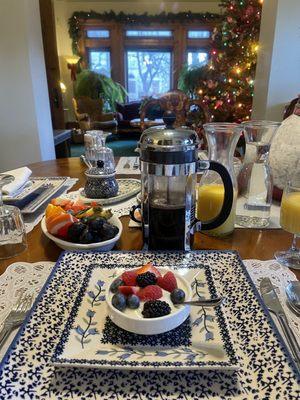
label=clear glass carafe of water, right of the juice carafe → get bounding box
[236,121,280,228]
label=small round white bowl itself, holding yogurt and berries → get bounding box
[106,268,192,335]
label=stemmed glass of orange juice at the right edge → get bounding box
[275,170,300,269]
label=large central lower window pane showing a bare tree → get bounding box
[126,49,171,101]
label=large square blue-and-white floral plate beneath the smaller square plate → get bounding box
[0,251,300,400]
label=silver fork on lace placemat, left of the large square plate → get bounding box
[0,294,33,350]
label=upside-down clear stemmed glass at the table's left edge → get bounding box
[0,175,27,259]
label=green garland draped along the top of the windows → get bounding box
[69,10,222,54]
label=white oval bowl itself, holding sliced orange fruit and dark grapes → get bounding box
[41,215,123,251]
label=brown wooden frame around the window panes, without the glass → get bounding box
[78,19,214,96]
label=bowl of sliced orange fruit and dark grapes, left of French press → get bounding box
[41,198,122,251]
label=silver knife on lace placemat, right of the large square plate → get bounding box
[260,278,300,369]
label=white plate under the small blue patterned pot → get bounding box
[64,178,141,205]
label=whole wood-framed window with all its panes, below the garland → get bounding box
[81,19,214,101]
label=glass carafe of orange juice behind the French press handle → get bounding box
[197,123,242,236]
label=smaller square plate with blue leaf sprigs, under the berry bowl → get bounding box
[52,263,238,370]
